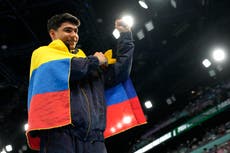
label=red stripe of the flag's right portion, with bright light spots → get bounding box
[104,97,146,138]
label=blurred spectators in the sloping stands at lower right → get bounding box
[132,80,230,153]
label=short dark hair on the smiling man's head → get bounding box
[47,13,80,32]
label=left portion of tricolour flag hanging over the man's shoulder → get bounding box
[26,40,86,150]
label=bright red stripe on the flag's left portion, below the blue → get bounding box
[28,90,71,130]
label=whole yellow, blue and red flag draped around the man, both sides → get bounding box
[26,40,146,150]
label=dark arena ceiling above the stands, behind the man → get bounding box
[0,0,230,153]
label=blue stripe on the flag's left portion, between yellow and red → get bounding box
[28,58,70,108]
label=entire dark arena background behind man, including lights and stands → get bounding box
[0,0,230,153]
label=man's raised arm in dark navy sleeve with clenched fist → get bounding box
[105,19,134,87]
